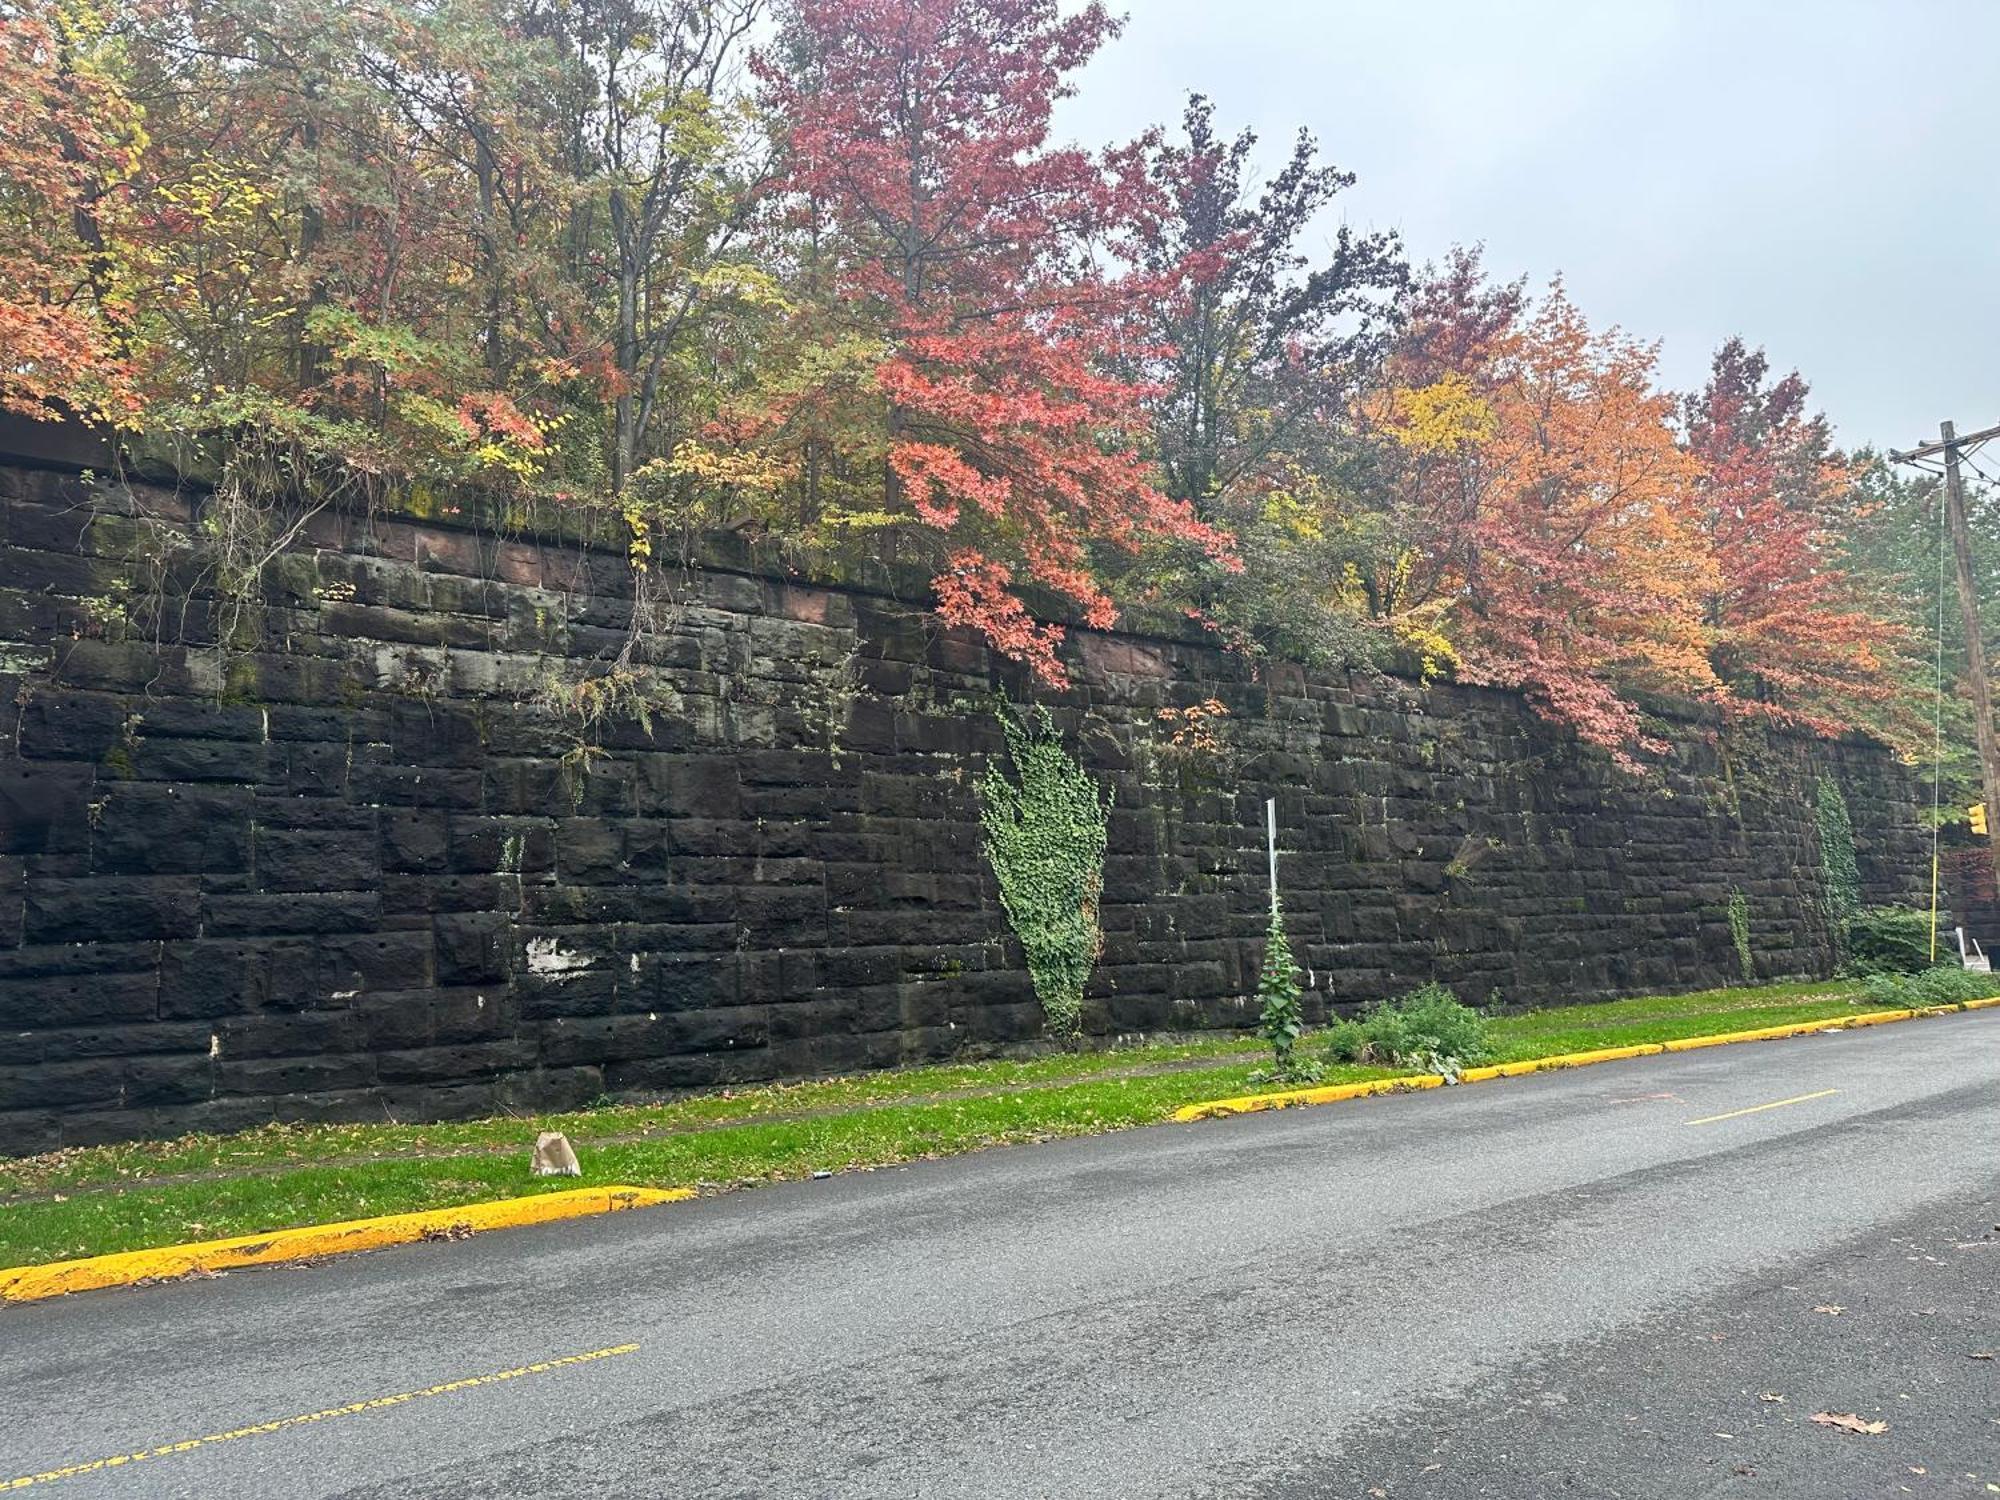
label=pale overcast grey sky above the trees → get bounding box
[1060,0,2000,458]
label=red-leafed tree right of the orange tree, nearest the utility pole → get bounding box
[1682,338,1904,732]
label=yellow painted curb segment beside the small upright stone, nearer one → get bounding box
[0,1188,694,1302]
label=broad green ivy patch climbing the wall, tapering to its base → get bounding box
[976,706,1112,1036]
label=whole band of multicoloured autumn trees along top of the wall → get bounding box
[0,0,1944,768]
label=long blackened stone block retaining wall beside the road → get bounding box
[0,454,1928,1152]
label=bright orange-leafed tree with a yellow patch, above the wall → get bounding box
[1378,266,1714,768]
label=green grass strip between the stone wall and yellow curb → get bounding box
[0,980,1968,1268]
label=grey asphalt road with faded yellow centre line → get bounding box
[0,1012,2000,1500]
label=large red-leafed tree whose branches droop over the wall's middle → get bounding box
[728,0,1228,682]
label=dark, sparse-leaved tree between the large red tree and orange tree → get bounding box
[1138,94,1408,660]
